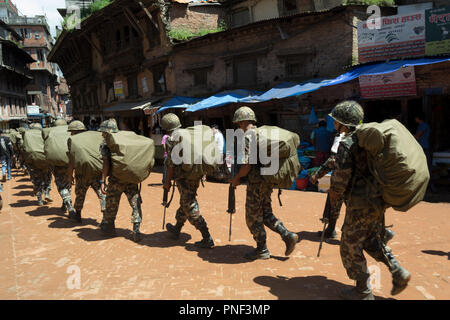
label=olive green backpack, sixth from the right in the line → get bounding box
[42,126,70,167]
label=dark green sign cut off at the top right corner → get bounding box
[425,7,450,55]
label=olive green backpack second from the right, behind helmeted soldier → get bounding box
[254,126,301,189]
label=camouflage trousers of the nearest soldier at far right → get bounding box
[340,200,391,280]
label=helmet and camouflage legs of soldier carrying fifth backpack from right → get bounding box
[68,120,106,222]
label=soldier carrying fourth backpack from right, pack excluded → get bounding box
[98,119,142,242]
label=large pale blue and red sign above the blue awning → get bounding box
[358,11,425,63]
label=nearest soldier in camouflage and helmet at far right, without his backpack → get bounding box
[329,101,411,300]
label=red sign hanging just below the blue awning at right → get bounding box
[359,66,416,99]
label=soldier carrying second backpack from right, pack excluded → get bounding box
[232,106,298,260]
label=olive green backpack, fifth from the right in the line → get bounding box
[67,131,103,180]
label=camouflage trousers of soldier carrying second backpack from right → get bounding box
[245,183,281,244]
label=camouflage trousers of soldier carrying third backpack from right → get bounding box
[175,179,206,230]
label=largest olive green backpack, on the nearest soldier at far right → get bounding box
[356,119,430,211]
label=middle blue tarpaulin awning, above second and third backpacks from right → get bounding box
[186,89,261,112]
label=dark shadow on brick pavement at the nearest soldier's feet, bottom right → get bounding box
[253,276,395,300]
